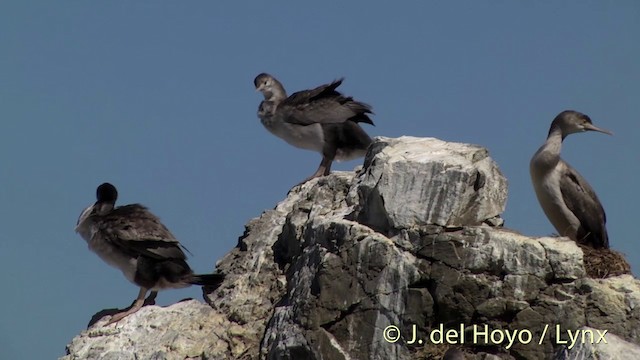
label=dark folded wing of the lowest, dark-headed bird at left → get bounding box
[98,204,186,259]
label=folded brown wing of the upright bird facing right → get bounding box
[560,163,609,248]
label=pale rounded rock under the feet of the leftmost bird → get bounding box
[62,300,228,360]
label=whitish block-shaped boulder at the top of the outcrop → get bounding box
[358,136,507,231]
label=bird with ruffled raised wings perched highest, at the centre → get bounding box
[254,73,373,183]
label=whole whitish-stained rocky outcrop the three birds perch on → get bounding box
[63,137,640,360]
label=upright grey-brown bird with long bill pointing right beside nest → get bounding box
[529,110,612,249]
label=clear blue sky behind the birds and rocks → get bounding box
[0,0,640,359]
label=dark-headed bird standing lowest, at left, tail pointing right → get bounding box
[75,183,224,325]
